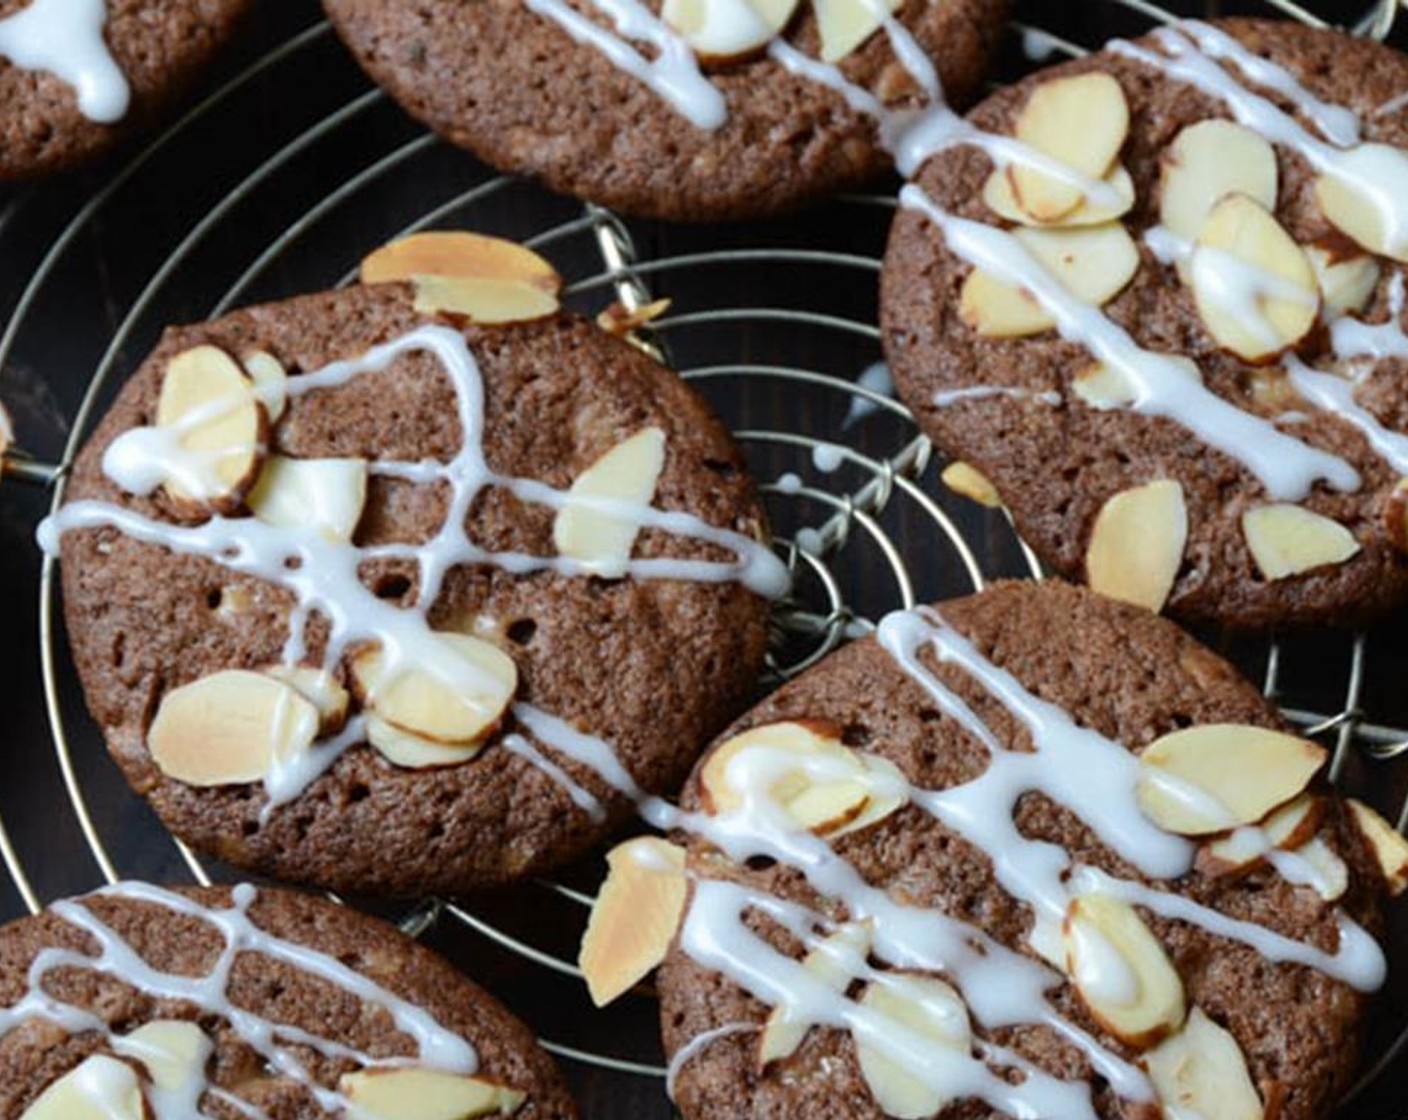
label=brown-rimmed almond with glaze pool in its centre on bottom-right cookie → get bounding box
[1064,895,1187,1050]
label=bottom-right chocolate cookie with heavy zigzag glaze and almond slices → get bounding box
[650,582,1402,1120]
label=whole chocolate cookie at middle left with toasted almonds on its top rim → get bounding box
[42,234,787,895]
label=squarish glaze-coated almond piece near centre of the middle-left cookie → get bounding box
[249,455,367,541]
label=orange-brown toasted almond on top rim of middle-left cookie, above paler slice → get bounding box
[362,230,562,297]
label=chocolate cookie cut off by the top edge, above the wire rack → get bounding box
[324,0,1008,221]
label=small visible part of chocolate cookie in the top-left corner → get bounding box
[0,0,253,180]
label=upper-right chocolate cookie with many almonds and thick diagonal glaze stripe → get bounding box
[883,20,1408,627]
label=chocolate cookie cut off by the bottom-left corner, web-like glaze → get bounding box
[0,883,577,1120]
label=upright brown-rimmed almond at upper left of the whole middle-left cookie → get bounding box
[156,345,269,513]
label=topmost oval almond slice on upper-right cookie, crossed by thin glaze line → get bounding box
[1007,72,1129,223]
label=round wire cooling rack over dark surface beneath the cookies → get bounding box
[0,0,1408,1120]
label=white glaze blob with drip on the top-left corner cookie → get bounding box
[0,0,132,124]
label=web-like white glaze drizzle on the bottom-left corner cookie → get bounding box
[0,883,479,1120]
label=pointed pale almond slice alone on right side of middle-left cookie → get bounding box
[552,428,665,579]
